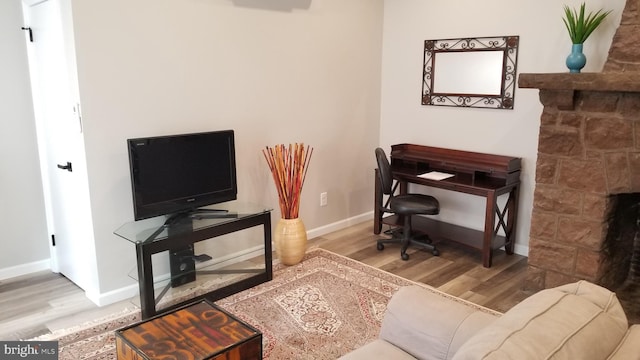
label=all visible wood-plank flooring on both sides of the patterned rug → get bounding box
[0,221,529,340]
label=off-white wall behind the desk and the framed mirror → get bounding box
[380,0,625,255]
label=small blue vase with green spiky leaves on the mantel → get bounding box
[562,3,611,73]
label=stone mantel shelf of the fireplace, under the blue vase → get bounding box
[518,72,640,92]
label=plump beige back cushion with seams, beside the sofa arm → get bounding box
[453,281,628,360]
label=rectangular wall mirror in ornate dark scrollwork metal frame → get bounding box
[422,36,520,109]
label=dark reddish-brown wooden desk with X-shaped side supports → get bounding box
[374,144,521,267]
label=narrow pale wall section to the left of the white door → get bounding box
[0,0,49,280]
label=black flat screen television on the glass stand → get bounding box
[127,130,238,220]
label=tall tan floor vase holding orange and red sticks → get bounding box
[262,143,313,265]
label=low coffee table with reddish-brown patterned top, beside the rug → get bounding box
[116,300,262,360]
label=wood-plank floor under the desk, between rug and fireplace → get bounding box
[310,222,531,312]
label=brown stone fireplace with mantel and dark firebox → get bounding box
[518,0,640,322]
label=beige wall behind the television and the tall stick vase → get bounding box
[67,0,383,293]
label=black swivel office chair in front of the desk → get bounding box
[376,148,440,260]
